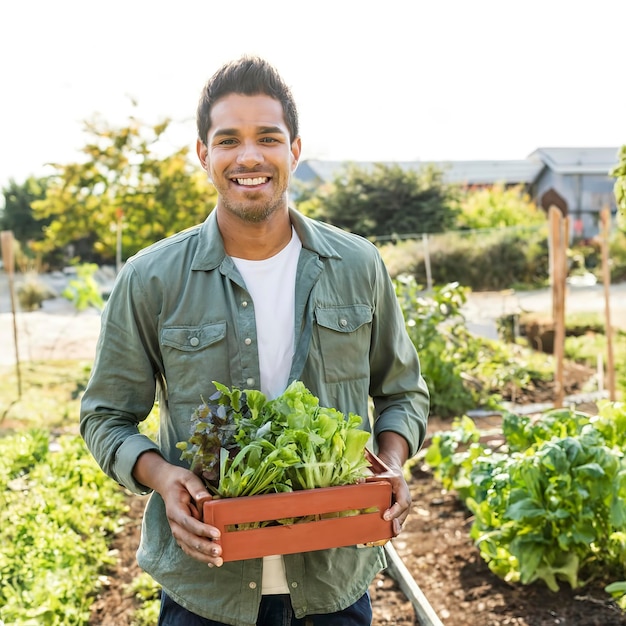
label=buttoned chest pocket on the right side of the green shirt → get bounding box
[315,304,372,382]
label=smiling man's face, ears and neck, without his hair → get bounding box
[197,93,300,254]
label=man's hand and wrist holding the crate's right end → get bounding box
[378,431,411,535]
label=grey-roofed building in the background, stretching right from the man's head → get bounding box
[294,147,619,238]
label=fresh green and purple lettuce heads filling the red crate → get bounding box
[177,381,369,498]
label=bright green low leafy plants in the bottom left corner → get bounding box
[0,430,125,626]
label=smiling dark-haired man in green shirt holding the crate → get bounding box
[81,57,428,626]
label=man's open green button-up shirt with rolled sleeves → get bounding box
[81,210,429,626]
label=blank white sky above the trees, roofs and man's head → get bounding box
[0,0,626,186]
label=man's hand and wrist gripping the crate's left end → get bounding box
[133,451,223,567]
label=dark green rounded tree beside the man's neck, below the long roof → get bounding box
[299,163,455,237]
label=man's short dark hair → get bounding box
[196,56,299,145]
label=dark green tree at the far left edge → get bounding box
[0,177,50,244]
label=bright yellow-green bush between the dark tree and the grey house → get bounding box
[456,184,546,230]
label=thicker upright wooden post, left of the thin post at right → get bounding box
[549,206,569,408]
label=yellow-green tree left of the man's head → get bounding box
[33,112,216,261]
